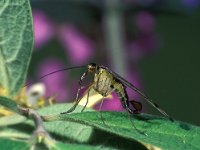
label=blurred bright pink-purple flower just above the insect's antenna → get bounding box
[60,25,94,65]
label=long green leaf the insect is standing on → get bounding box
[56,112,200,150]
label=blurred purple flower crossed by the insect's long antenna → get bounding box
[38,59,68,102]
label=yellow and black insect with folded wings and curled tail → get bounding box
[61,63,173,121]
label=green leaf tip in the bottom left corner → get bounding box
[0,138,29,150]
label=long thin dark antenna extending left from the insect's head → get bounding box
[24,66,86,87]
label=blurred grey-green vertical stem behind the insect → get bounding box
[103,0,126,76]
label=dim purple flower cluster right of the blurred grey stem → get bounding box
[127,11,158,61]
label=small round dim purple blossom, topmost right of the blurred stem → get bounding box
[135,11,155,34]
